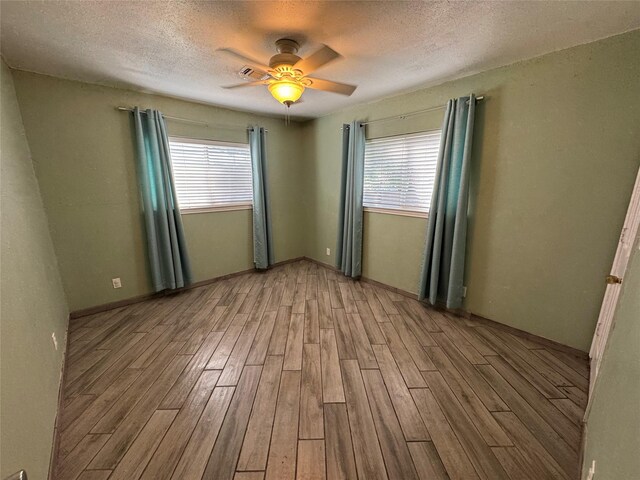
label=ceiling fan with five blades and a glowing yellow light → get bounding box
[223,38,356,108]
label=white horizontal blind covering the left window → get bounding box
[169,137,253,210]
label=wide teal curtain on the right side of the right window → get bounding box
[419,94,476,308]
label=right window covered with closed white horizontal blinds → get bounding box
[364,130,440,216]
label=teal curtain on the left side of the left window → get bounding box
[133,107,191,292]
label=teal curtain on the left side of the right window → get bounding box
[336,122,365,278]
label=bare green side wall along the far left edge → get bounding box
[0,60,69,479]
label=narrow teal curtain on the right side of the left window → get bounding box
[249,127,274,269]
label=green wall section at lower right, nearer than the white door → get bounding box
[583,235,640,480]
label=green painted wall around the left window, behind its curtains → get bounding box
[14,71,304,310]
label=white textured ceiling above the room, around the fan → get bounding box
[0,1,640,118]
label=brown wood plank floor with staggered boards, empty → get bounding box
[55,261,589,480]
